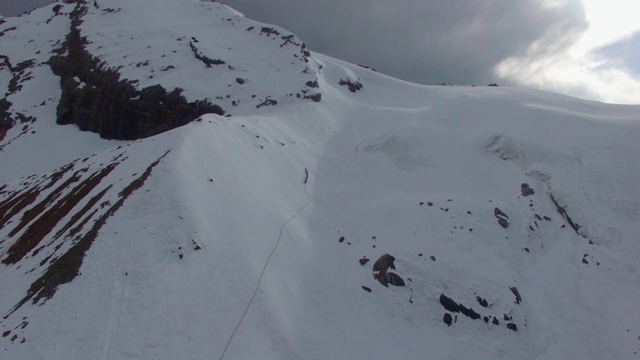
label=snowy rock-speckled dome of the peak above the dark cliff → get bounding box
[75,0,316,112]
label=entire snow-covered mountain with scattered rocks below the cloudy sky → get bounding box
[0,0,640,359]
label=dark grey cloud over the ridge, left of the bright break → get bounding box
[222,0,587,84]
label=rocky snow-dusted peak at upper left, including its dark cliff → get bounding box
[0,0,321,139]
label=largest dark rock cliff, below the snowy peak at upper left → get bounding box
[49,2,224,140]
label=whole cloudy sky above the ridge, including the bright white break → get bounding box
[0,0,640,104]
